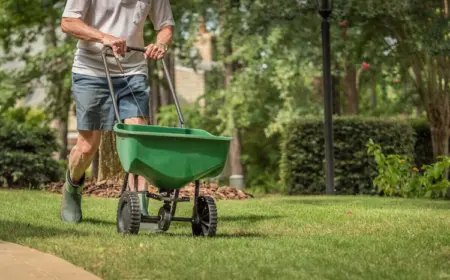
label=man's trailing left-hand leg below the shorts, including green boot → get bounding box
[60,131,101,223]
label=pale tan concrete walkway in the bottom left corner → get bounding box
[0,240,100,280]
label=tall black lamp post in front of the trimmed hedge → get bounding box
[317,0,334,194]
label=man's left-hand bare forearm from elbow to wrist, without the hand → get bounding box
[61,18,105,43]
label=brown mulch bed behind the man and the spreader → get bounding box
[47,180,253,200]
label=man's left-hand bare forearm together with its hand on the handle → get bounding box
[61,17,126,56]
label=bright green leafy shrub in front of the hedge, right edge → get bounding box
[367,139,450,198]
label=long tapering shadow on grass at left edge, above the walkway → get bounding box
[0,219,87,242]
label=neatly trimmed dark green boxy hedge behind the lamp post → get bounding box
[280,117,415,194]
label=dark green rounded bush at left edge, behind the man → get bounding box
[0,109,62,188]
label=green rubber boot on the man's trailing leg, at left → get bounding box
[60,171,85,223]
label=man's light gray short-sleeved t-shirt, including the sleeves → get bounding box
[62,0,174,77]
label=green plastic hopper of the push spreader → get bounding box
[114,123,231,189]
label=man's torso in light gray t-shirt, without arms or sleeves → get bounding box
[63,0,152,76]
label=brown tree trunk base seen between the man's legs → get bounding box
[97,131,125,184]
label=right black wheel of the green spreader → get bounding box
[192,196,217,237]
